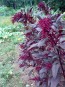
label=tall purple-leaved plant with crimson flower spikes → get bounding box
[12,2,65,87]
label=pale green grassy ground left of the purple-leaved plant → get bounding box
[0,8,25,87]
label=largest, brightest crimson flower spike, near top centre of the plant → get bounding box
[38,18,52,37]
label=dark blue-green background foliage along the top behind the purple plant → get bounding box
[0,0,65,12]
